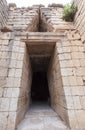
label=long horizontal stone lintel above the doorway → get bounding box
[15,32,65,43]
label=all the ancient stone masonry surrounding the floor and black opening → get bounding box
[0,0,85,130]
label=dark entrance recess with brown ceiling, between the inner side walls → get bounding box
[27,43,55,105]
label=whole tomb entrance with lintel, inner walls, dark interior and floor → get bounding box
[17,33,68,130]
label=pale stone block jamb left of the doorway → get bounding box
[5,40,25,130]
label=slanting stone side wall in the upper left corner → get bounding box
[0,0,8,29]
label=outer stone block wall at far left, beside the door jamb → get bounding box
[0,33,12,130]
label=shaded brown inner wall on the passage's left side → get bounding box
[16,45,32,125]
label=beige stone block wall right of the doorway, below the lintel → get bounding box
[57,35,85,129]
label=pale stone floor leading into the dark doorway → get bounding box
[17,102,68,130]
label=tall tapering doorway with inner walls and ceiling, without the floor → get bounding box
[15,32,68,130]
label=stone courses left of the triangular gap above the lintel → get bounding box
[7,4,39,32]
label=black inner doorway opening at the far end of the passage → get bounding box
[31,71,49,102]
